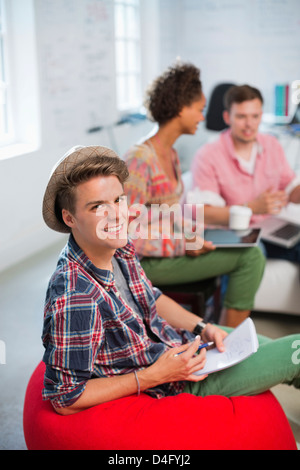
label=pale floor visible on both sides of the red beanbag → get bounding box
[0,244,300,450]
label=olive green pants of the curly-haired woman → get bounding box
[141,247,265,310]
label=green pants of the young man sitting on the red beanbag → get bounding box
[184,327,300,403]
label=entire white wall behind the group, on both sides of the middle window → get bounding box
[0,0,300,271]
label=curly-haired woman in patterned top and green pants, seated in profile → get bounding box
[125,64,265,327]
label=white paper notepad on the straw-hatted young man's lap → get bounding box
[195,317,259,375]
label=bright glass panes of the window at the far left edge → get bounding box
[0,0,12,145]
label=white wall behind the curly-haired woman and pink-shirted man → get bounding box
[160,0,300,169]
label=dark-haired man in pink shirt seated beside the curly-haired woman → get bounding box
[192,85,300,263]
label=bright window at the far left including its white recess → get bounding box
[0,0,40,159]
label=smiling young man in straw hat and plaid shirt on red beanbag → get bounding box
[43,147,300,414]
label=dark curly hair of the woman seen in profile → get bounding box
[144,63,202,124]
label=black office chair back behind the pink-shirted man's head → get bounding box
[205,83,235,131]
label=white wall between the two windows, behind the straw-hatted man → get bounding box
[0,0,153,271]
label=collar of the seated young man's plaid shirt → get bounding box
[67,234,135,290]
